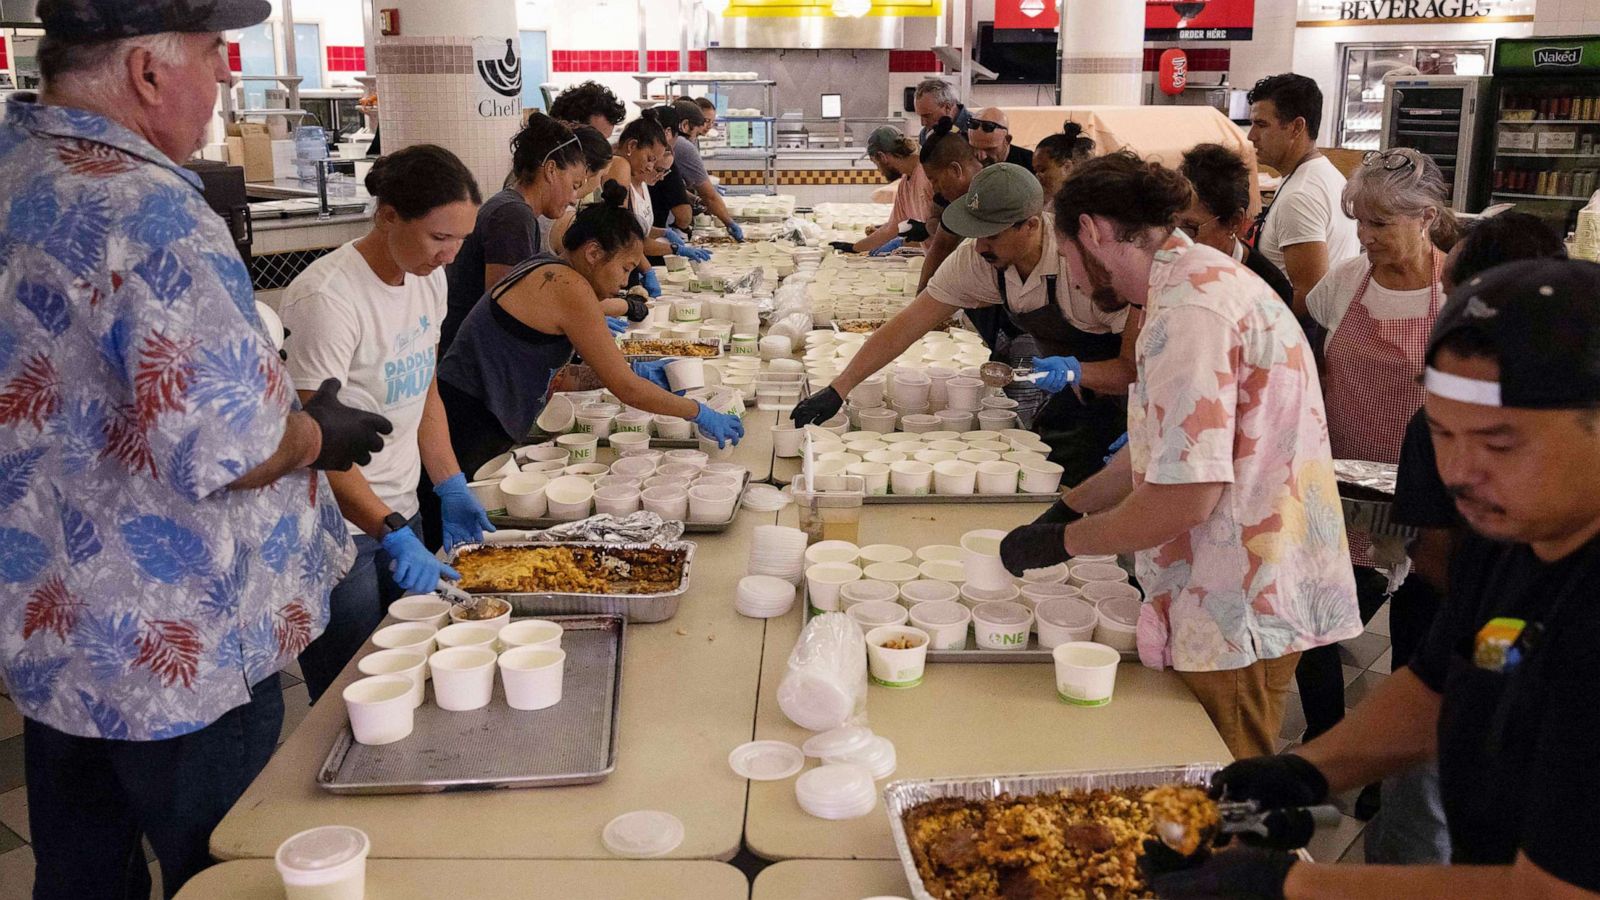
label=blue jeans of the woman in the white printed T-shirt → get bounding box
[299,516,418,703]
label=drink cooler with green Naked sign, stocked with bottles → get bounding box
[1478,35,1600,235]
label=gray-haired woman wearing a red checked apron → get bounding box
[1296,147,1456,740]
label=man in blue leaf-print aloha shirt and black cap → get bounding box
[0,0,387,898]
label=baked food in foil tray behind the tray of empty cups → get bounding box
[451,544,688,594]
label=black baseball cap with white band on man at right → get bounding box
[1424,253,1600,410]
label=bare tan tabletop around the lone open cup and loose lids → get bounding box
[744,503,1230,860]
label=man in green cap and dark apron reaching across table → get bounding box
[794,163,1138,484]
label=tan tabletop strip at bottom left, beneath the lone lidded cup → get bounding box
[178,860,749,900]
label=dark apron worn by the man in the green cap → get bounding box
[995,272,1128,485]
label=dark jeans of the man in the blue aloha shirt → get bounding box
[22,673,283,900]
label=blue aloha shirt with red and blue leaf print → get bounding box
[0,96,350,740]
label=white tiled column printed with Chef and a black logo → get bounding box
[373,0,523,197]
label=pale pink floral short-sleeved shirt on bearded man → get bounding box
[1128,232,1362,671]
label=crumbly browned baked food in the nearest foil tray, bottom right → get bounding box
[904,785,1216,900]
